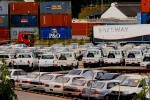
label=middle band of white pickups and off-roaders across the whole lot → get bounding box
[0,43,150,70]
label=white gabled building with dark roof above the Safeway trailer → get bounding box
[101,3,140,19]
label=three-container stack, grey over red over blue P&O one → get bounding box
[40,1,72,39]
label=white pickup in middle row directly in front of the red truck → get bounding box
[13,52,38,70]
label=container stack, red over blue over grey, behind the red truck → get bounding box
[10,2,39,39]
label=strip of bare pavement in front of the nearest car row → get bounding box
[16,91,68,100]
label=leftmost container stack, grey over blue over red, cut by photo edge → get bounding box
[0,1,10,39]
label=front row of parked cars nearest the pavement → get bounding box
[9,68,150,100]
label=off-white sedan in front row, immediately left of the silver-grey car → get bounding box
[63,79,95,96]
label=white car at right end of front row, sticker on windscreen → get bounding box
[108,75,149,100]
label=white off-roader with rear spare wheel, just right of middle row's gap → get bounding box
[82,49,104,68]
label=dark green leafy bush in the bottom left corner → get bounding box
[0,60,17,100]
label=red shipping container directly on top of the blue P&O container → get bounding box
[40,14,72,27]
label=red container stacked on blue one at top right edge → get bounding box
[138,0,150,24]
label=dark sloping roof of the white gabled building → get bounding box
[115,3,140,17]
